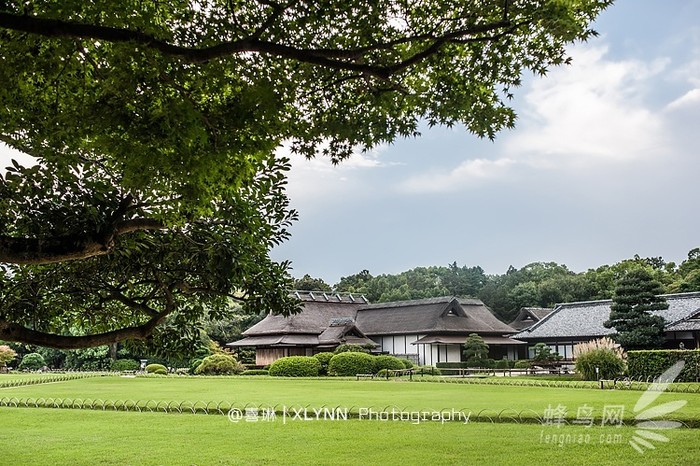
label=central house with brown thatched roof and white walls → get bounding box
[228,292,523,365]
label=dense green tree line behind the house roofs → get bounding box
[295,248,700,322]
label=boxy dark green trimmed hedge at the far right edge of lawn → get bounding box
[627,350,700,382]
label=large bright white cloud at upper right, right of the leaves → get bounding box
[505,47,667,168]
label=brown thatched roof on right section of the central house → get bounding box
[357,297,514,335]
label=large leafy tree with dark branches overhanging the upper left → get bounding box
[0,0,611,348]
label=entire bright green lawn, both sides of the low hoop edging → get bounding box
[0,377,700,465]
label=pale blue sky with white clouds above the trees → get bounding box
[0,0,700,285]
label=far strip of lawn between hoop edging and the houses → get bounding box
[0,377,700,424]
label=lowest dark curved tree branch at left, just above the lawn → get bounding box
[0,310,170,349]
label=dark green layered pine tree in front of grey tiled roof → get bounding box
[605,268,668,350]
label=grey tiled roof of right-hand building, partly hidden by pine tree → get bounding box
[513,292,700,340]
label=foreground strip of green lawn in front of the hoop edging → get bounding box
[0,408,700,466]
